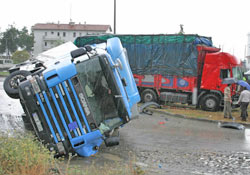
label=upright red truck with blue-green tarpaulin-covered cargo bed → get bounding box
[75,34,243,111]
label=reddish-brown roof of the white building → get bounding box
[32,22,111,32]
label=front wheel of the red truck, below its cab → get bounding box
[201,94,220,111]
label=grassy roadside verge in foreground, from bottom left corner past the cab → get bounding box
[0,134,145,175]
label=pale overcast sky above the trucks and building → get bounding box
[0,0,250,60]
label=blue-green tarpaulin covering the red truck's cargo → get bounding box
[75,34,212,76]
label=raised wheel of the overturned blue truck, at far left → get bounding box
[3,70,31,99]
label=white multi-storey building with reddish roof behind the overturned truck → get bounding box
[32,22,112,56]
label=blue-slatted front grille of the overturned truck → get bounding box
[35,79,91,147]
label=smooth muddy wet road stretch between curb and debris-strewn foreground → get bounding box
[127,115,250,152]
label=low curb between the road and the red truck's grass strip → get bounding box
[148,108,250,126]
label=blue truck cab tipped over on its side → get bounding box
[18,38,140,156]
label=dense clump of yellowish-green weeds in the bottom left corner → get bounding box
[0,134,55,175]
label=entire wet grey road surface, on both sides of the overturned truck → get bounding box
[0,78,250,175]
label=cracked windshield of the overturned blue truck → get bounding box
[76,57,125,129]
